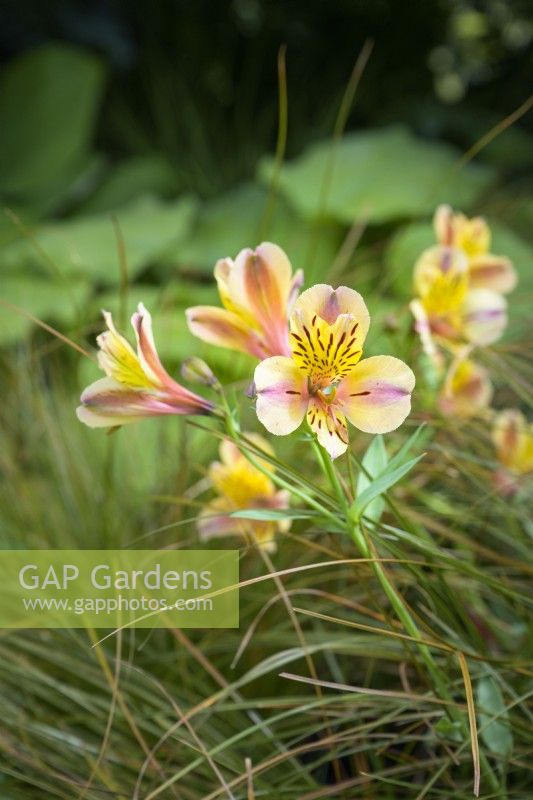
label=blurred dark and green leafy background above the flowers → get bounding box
[0,0,533,358]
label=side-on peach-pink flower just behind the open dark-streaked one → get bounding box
[186,242,303,359]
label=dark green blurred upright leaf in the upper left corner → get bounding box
[0,45,104,198]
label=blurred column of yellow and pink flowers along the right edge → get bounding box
[410,205,533,494]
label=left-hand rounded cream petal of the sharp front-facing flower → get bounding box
[254,356,309,436]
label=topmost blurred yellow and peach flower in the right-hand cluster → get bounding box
[433,205,517,293]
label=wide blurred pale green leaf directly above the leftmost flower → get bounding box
[0,197,196,285]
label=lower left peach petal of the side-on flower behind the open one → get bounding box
[185,306,268,358]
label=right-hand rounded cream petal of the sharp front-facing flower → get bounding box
[337,356,415,433]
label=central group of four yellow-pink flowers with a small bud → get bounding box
[77,242,415,549]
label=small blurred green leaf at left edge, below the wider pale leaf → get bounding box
[0,275,90,345]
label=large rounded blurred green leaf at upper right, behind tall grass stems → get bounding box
[259,126,494,224]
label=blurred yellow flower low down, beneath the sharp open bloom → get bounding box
[198,433,291,552]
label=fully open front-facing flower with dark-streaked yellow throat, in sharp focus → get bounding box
[255,284,415,458]
